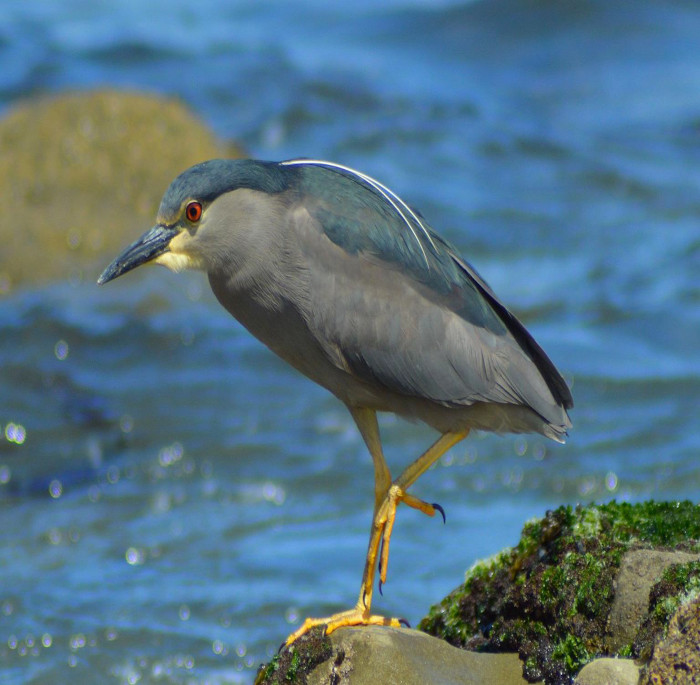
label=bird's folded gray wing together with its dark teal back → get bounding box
[288,162,572,425]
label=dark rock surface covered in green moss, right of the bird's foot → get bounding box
[419,502,700,683]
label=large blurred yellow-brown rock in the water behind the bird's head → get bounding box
[0,90,242,295]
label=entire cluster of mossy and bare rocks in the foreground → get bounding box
[257,502,700,685]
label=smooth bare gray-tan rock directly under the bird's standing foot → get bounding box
[307,626,527,685]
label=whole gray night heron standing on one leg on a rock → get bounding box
[97,158,573,645]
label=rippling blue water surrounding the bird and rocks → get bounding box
[0,0,700,683]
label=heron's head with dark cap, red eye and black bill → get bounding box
[97,159,288,285]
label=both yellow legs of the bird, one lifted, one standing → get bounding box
[286,408,468,646]
